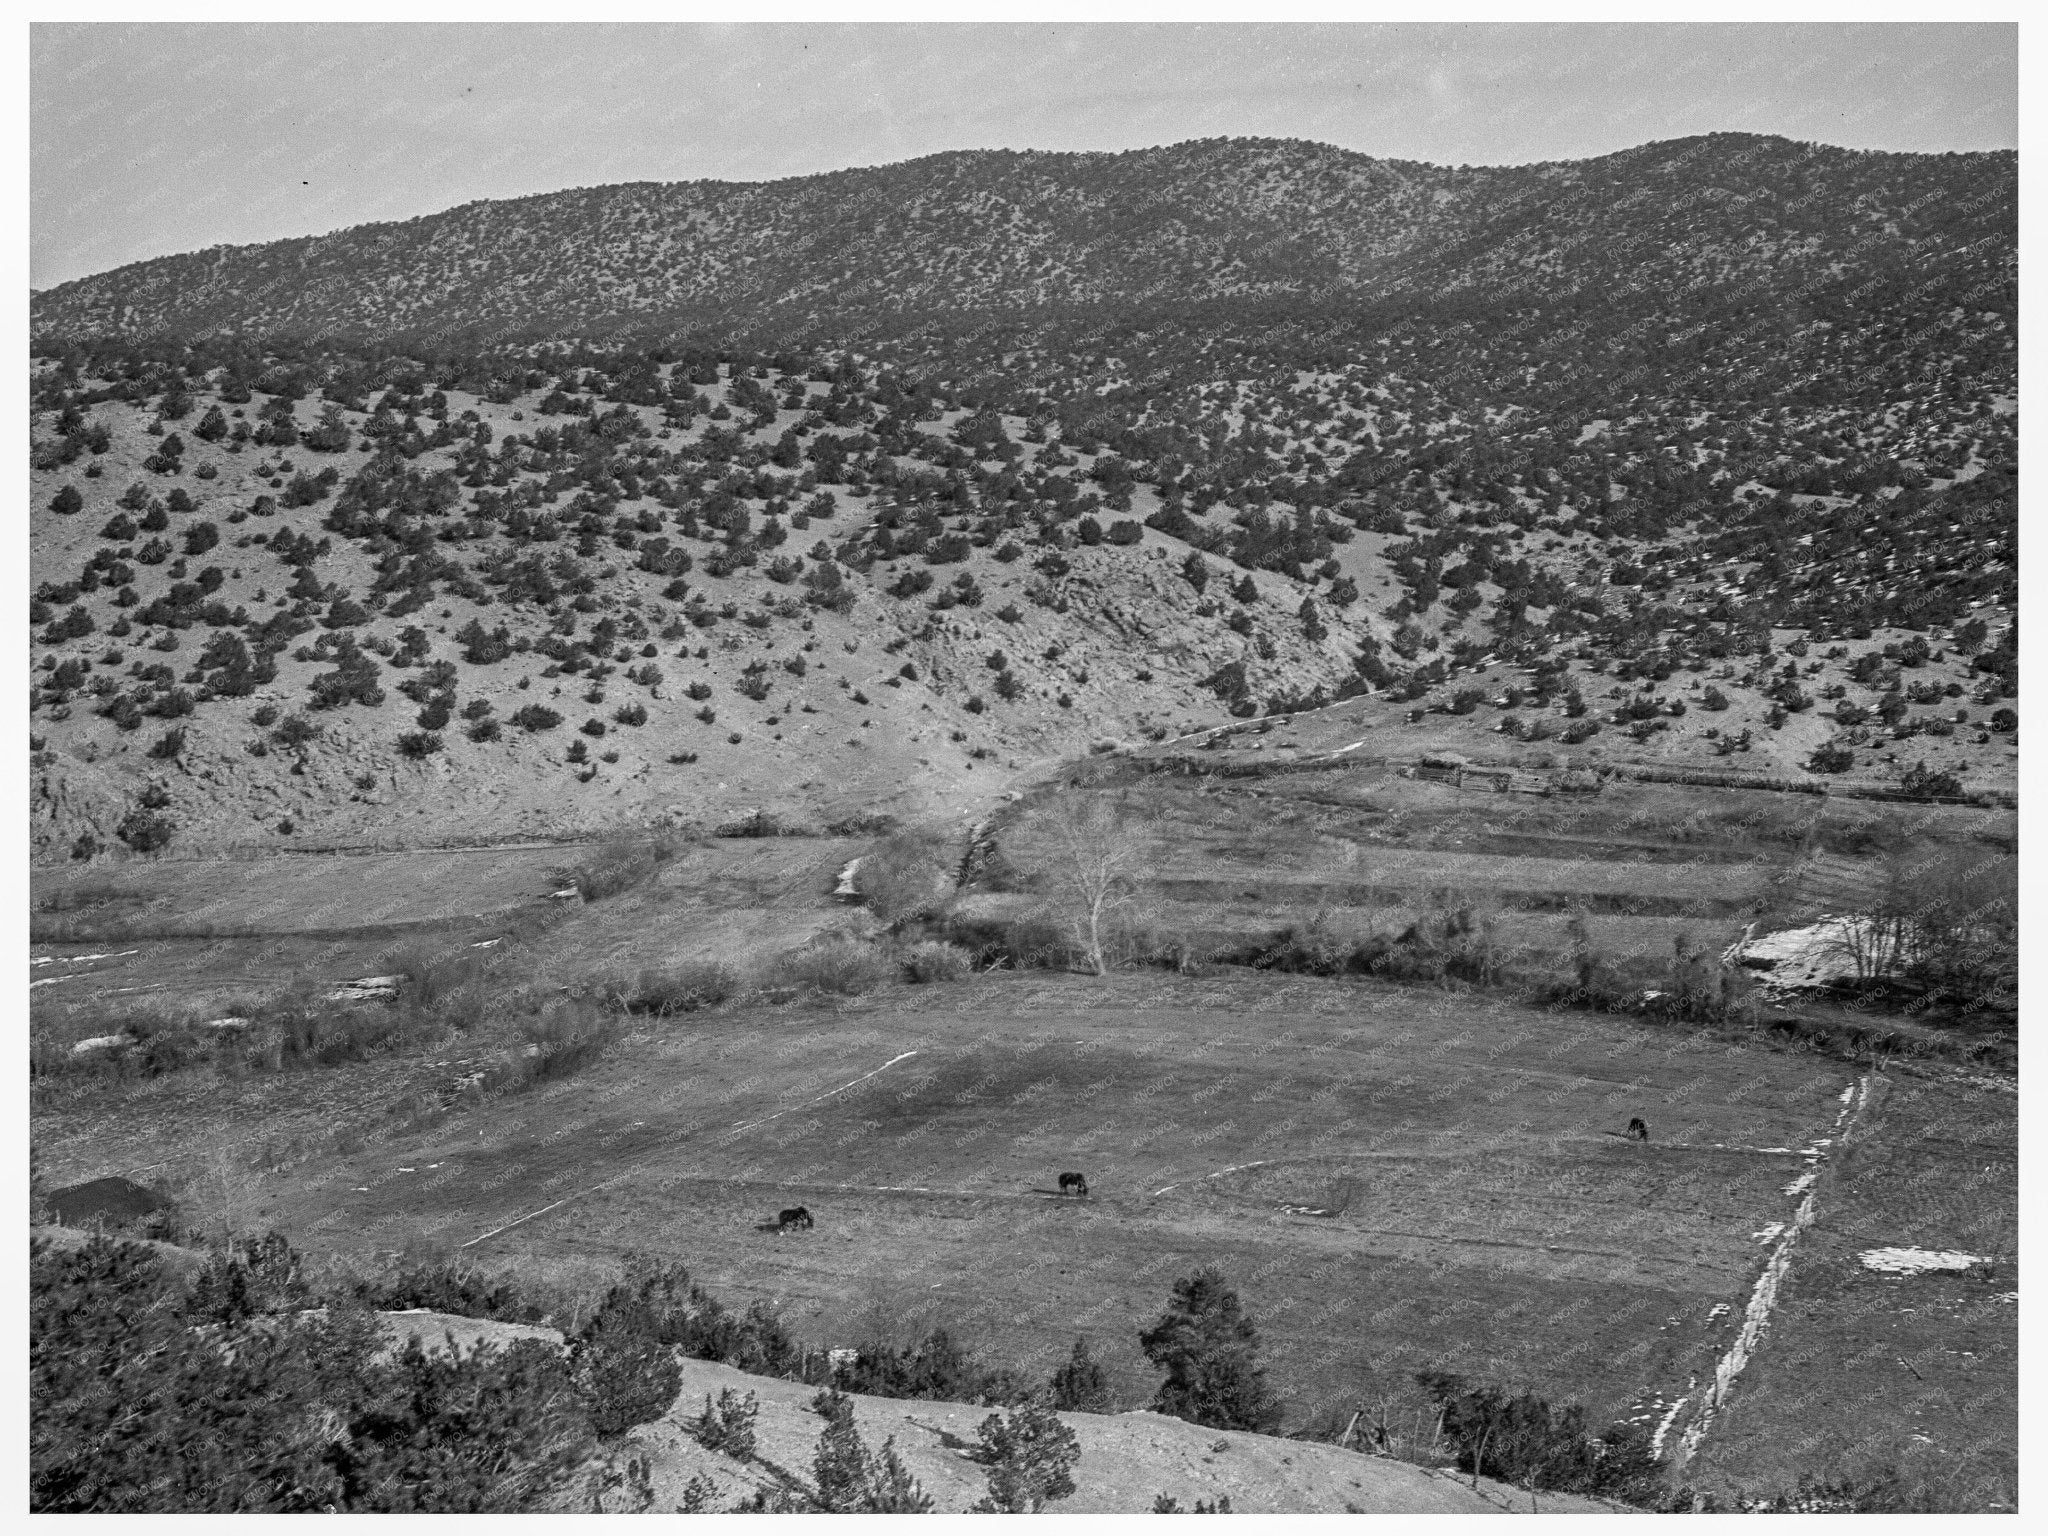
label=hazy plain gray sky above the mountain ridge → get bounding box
[31,23,2019,289]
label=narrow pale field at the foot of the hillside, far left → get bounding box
[29,838,866,1047]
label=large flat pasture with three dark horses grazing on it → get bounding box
[59,973,1875,1458]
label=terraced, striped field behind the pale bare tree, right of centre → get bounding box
[987,761,2017,987]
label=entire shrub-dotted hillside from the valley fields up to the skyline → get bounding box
[31,135,2017,858]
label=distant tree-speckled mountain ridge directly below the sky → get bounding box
[31,135,2015,356]
